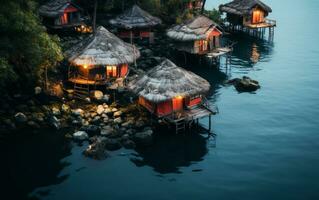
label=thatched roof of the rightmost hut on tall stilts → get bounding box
[219,0,272,16]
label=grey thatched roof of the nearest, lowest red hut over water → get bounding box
[128,59,210,103]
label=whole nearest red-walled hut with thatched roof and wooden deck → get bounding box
[128,59,215,132]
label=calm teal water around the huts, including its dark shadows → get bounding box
[0,0,319,200]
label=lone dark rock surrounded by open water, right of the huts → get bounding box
[227,76,260,92]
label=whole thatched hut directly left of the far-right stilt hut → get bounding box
[167,15,232,64]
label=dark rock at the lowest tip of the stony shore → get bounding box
[83,137,108,160]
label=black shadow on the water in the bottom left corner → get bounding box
[0,130,71,200]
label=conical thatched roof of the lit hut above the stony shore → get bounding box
[66,26,140,65]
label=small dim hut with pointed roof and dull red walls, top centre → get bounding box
[110,5,162,41]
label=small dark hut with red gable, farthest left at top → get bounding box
[39,0,83,29]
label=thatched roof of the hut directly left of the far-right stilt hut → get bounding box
[167,15,219,41]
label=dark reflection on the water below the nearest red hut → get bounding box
[131,133,209,174]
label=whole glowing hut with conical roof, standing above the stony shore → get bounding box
[66,27,140,98]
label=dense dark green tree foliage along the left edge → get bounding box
[0,0,63,93]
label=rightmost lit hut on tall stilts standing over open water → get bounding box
[219,0,276,39]
